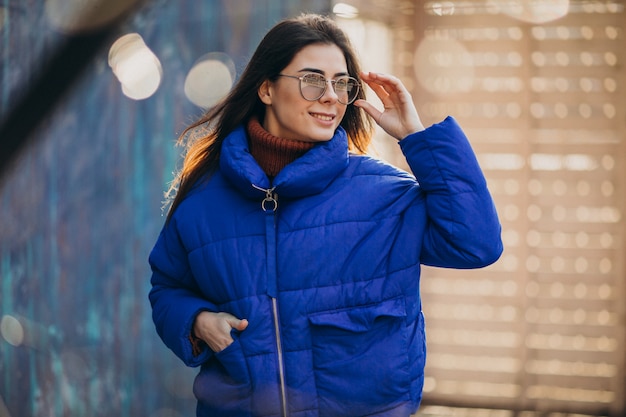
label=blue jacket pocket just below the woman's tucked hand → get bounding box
[193,338,252,415]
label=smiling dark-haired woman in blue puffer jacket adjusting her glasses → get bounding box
[150,15,502,417]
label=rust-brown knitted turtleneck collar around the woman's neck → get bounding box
[248,118,315,178]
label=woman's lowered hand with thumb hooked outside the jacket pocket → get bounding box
[193,311,248,352]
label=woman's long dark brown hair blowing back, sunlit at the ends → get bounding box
[167,14,373,220]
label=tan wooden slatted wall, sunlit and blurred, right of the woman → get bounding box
[386,0,626,417]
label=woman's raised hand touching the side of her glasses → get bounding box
[354,72,424,140]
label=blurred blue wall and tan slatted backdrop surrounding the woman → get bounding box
[0,0,626,417]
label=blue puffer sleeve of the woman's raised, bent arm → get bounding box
[400,117,503,269]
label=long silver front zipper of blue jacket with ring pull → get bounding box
[252,184,288,417]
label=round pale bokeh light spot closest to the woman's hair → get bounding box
[184,52,237,108]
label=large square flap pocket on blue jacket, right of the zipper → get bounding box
[309,298,410,417]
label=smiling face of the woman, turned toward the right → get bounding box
[259,44,348,142]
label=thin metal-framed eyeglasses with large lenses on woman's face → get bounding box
[278,72,359,105]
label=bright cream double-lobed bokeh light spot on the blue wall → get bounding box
[109,33,163,100]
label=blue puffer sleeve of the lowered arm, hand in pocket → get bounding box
[149,217,217,366]
